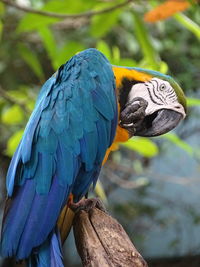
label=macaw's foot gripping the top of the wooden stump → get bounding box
[69,198,106,213]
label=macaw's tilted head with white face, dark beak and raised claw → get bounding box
[113,66,186,137]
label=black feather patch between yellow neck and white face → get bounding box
[119,78,141,112]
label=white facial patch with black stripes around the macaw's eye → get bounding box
[128,78,186,118]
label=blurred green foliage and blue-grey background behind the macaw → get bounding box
[0,0,200,267]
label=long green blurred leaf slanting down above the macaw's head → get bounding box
[133,12,159,70]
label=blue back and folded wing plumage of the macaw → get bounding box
[1,49,118,259]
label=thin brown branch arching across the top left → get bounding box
[0,0,132,19]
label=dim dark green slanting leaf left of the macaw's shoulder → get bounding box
[18,43,44,80]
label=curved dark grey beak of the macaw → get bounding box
[134,109,183,137]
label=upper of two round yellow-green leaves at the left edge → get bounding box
[1,105,24,125]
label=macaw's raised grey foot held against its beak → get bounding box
[120,97,148,135]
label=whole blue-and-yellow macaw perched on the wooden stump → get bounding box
[0,48,186,267]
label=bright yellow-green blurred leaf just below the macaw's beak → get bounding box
[121,137,158,158]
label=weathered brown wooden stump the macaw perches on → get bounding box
[73,199,147,267]
